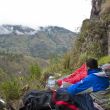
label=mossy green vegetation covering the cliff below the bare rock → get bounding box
[72,19,107,66]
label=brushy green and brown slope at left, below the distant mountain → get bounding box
[0,52,44,100]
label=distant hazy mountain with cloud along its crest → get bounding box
[0,25,77,59]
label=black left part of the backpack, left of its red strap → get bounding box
[19,90,53,110]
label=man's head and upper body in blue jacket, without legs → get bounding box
[67,58,109,95]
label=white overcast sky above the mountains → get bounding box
[0,0,91,31]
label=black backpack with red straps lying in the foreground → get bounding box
[19,90,78,110]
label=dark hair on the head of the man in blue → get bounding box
[86,58,98,69]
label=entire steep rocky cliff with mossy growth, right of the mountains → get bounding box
[75,0,110,58]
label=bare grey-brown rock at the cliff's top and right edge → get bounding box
[90,0,110,55]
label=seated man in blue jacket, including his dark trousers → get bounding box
[58,58,109,110]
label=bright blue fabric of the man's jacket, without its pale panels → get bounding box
[67,69,109,95]
